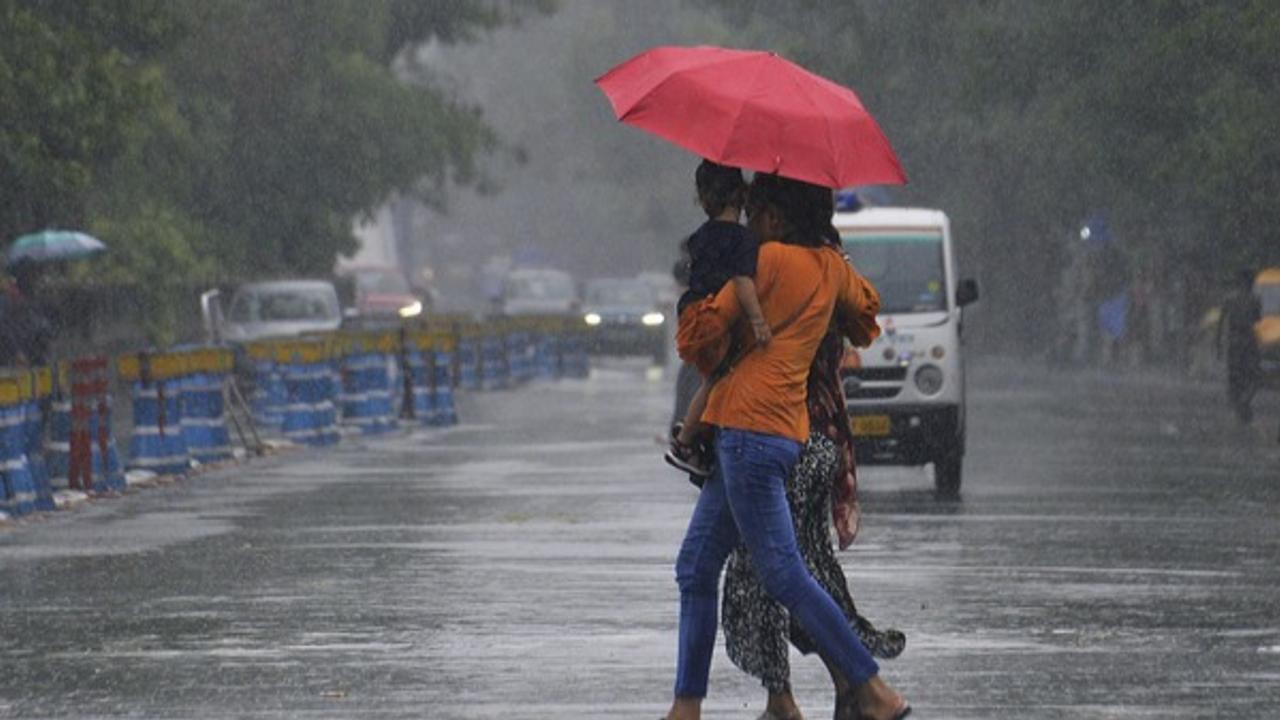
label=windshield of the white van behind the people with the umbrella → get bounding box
[840,229,947,314]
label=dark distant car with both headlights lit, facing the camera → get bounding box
[582,278,667,364]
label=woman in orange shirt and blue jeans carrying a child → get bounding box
[667,174,910,720]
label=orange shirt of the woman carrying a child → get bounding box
[681,242,879,442]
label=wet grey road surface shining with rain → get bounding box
[0,363,1280,720]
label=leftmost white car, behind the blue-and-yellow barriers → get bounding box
[201,281,342,342]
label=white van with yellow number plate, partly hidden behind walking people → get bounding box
[835,208,978,496]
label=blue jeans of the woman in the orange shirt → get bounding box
[676,429,879,698]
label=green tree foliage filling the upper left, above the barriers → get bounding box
[0,0,552,334]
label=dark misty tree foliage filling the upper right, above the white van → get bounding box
[719,0,1280,345]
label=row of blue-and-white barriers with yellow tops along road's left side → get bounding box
[0,308,589,518]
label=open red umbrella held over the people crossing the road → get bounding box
[595,46,906,187]
